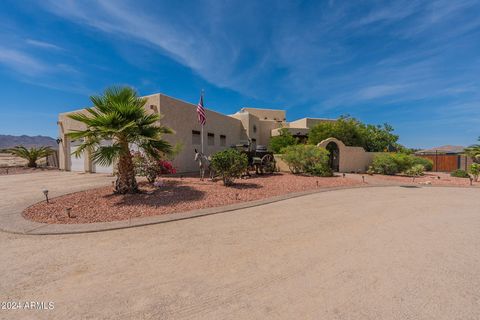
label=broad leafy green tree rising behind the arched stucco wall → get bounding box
[308,116,401,152]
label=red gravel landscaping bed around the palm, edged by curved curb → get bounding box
[23,173,361,224]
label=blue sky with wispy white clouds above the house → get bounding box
[0,0,480,147]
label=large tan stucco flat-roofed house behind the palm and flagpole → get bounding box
[58,94,335,173]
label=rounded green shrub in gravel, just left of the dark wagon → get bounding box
[210,149,248,186]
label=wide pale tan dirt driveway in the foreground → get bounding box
[0,187,480,319]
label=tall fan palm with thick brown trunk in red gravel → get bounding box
[67,87,173,194]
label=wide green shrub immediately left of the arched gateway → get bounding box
[282,144,333,177]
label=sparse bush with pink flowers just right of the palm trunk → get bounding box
[132,152,177,183]
